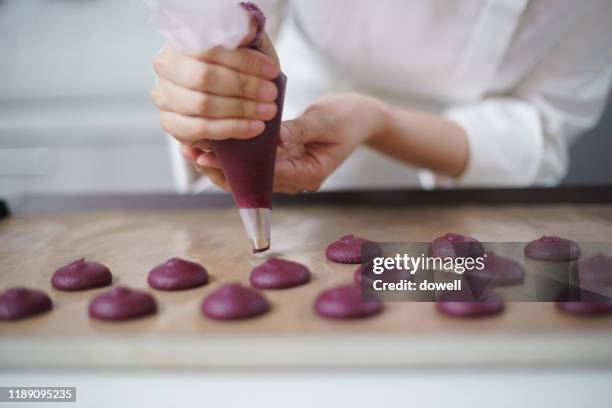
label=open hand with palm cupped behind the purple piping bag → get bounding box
[182,94,388,194]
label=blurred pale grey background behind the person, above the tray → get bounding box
[0,0,612,207]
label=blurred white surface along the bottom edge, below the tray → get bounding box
[0,367,612,408]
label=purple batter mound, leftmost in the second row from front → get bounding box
[51,258,113,291]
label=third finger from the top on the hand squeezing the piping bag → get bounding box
[151,79,277,120]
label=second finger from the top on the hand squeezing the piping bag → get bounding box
[153,47,278,102]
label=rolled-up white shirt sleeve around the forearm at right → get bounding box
[440,4,612,186]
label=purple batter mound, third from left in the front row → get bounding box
[202,283,270,320]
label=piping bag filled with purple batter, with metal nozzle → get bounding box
[144,0,287,252]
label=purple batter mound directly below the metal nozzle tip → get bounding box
[250,258,310,289]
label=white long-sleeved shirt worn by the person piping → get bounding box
[167,0,612,191]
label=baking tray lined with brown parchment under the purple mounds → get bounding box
[0,188,612,368]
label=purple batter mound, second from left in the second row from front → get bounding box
[148,258,209,290]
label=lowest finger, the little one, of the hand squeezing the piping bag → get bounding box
[159,111,265,146]
